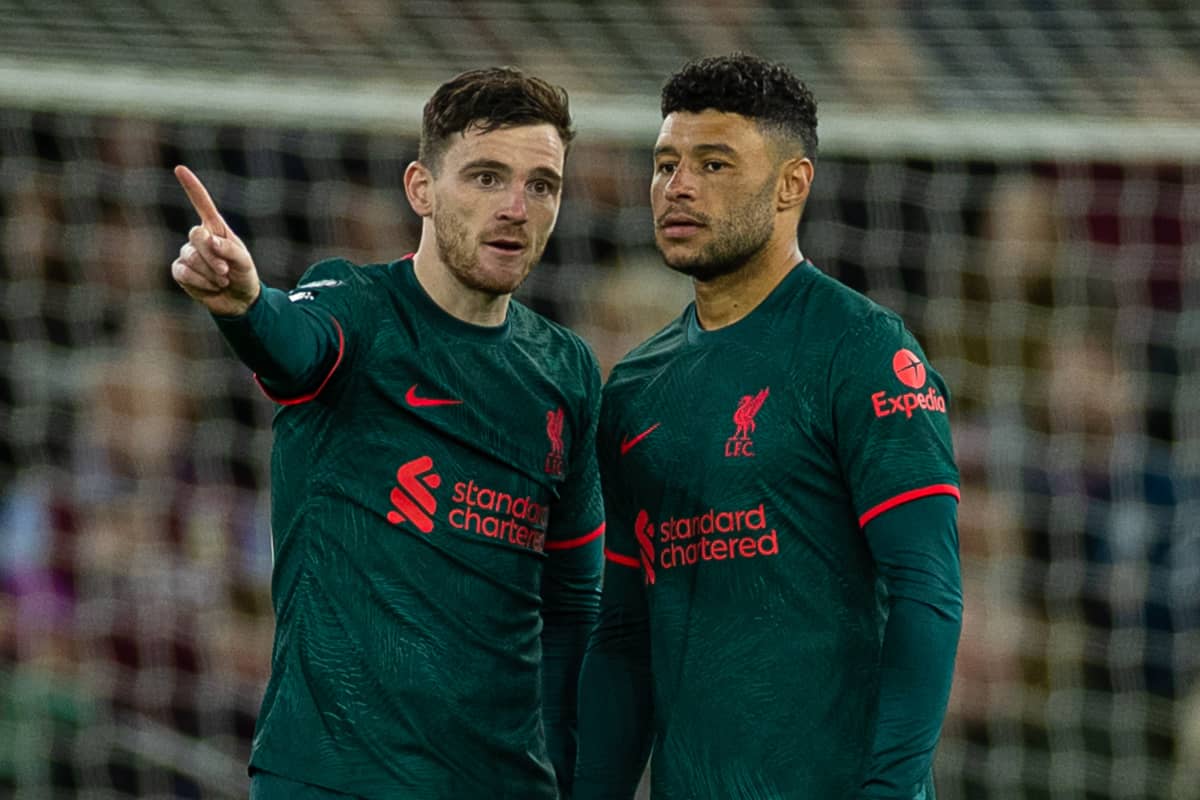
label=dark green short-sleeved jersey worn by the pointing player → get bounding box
[244,260,604,800]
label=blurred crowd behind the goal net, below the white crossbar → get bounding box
[0,112,1200,800]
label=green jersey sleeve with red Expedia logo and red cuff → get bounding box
[828,309,959,527]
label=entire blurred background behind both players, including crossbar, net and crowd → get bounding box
[0,0,1200,800]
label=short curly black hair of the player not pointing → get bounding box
[662,53,817,161]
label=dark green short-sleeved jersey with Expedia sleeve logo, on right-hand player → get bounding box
[598,263,958,800]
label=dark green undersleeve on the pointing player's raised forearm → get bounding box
[212,287,342,396]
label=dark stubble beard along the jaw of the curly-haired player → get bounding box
[659,179,775,283]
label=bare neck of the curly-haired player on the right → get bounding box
[692,236,804,331]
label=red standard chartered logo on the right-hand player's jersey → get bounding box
[634,503,779,575]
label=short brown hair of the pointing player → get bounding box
[416,67,575,172]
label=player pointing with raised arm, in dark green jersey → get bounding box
[172,68,604,800]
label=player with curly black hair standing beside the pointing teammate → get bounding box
[575,54,961,800]
